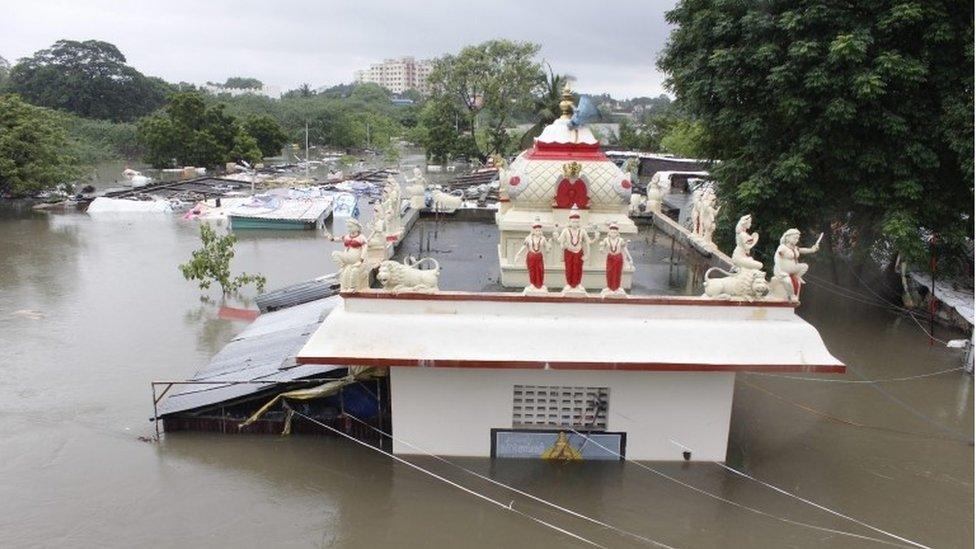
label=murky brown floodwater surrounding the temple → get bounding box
[0,179,973,548]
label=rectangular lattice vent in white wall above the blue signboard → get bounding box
[512,385,610,431]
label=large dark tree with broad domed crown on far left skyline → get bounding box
[7,40,168,121]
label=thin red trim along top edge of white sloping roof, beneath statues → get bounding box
[341,290,798,308]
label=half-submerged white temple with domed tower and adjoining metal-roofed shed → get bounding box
[157,89,845,461]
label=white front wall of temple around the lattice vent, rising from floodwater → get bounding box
[390,367,735,461]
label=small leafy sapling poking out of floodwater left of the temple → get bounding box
[179,223,267,295]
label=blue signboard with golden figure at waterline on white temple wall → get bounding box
[491,429,627,461]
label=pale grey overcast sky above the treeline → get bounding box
[0,0,674,98]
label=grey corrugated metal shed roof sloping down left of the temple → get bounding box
[158,296,345,416]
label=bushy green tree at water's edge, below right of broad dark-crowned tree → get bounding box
[137,92,261,167]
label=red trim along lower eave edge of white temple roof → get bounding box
[298,356,847,374]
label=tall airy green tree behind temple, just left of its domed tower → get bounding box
[429,40,541,158]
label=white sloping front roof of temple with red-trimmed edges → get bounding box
[297,291,844,373]
